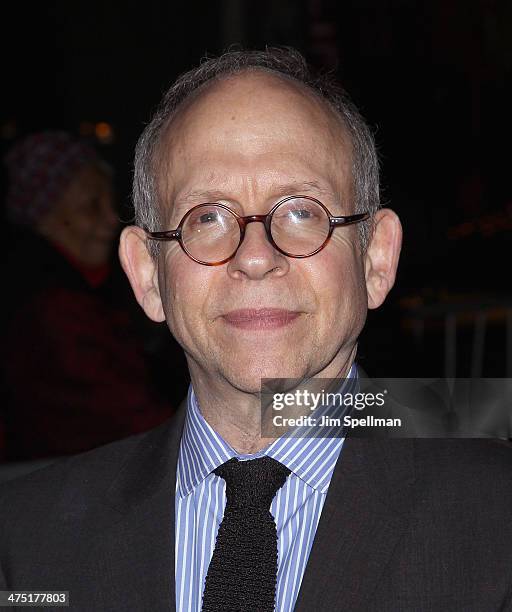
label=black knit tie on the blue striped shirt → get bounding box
[202,457,290,612]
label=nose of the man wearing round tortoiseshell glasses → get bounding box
[228,223,290,280]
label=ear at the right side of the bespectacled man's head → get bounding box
[365,208,402,308]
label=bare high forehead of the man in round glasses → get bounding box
[158,71,351,214]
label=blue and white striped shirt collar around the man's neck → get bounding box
[176,364,357,498]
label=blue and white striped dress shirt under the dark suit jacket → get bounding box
[175,366,357,612]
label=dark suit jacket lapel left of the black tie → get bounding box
[84,403,186,612]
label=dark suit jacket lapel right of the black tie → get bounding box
[295,437,414,612]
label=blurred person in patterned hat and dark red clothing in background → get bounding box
[3,132,171,460]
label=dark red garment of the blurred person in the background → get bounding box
[3,233,172,460]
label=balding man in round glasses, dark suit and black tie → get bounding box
[1,50,512,612]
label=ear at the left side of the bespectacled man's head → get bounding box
[119,225,165,323]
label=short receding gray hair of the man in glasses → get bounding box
[133,47,379,256]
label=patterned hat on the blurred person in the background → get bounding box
[5,132,99,226]
